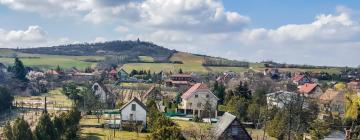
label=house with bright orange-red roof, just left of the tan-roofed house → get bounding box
[298,83,323,98]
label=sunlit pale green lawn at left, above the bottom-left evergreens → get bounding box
[15,88,72,108]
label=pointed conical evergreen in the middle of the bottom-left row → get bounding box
[34,111,59,140]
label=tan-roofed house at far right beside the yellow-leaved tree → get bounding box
[319,89,345,114]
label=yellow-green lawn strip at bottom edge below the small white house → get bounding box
[81,128,149,140]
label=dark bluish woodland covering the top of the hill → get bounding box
[18,40,175,58]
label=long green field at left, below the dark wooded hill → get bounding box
[0,50,104,69]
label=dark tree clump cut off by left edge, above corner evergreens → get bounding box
[0,86,14,112]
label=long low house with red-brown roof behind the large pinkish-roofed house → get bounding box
[165,74,194,87]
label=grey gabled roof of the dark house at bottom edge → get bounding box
[212,112,251,139]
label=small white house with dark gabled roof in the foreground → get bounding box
[119,97,147,128]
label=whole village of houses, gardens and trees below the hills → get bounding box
[0,59,360,140]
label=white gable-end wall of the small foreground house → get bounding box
[121,101,146,125]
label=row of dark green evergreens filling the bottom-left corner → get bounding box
[3,108,81,140]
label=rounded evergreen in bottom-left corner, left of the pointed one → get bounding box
[12,118,33,140]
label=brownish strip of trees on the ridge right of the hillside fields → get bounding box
[203,57,249,68]
